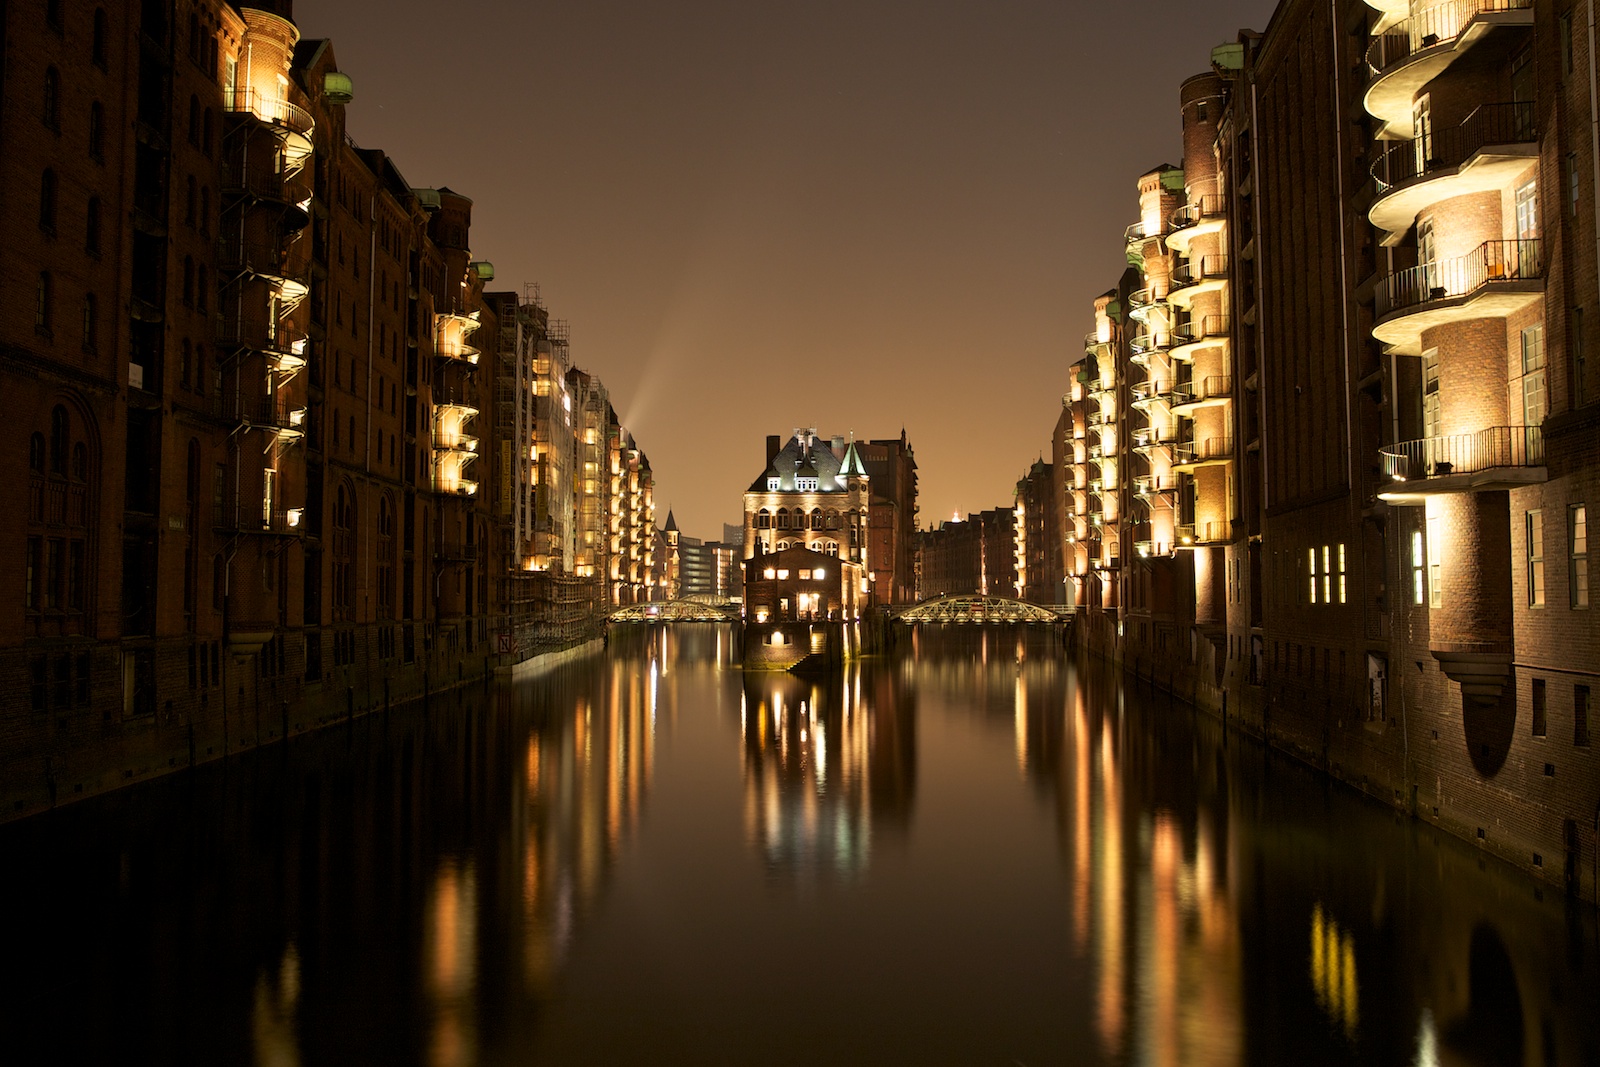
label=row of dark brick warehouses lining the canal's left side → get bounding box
[0,0,654,819]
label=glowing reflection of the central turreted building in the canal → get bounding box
[739,664,917,885]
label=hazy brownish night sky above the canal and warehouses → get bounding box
[294,0,1274,539]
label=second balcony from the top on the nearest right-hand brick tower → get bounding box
[1368,101,1539,245]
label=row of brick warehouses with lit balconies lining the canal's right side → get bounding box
[1056,0,1600,901]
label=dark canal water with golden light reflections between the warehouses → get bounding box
[0,627,1600,1067]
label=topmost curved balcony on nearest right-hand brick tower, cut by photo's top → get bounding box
[1363,0,1533,138]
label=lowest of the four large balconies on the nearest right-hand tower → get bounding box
[1378,426,1546,504]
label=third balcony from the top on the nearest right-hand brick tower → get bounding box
[1373,238,1544,355]
